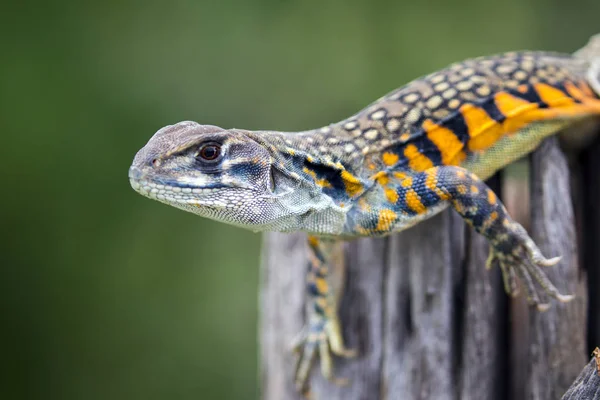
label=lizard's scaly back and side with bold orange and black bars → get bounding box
[319,46,600,179]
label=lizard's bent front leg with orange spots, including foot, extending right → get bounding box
[352,166,573,311]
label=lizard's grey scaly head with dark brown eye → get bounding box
[129,121,285,230]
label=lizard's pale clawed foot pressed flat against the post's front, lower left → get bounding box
[293,317,356,398]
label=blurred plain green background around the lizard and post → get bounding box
[0,0,600,400]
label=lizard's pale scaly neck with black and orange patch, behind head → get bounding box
[237,125,371,235]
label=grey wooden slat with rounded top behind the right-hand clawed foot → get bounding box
[526,138,587,400]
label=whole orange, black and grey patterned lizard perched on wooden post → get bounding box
[129,35,600,394]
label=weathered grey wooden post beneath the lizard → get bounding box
[260,139,600,400]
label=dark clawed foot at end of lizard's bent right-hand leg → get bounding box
[486,235,575,311]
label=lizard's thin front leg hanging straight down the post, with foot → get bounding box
[294,236,355,396]
